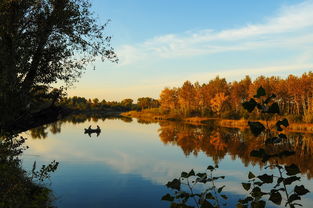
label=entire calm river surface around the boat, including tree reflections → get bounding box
[23,118,313,208]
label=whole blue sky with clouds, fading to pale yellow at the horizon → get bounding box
[68,0,313,101]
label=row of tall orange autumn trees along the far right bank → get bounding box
[159,72,313,122]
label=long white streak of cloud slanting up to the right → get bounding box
[118,0,313,65]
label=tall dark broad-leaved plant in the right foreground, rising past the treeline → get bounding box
[237,87,309,208]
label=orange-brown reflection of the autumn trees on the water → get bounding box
[159,122,313,179]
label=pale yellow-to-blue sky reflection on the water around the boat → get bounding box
[23,120,313,208]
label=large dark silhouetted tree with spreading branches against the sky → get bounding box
[0,0,118,125]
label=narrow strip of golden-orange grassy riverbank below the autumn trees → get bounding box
[121,111,313,134]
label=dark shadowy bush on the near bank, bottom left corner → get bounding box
[0,135,58,208]
